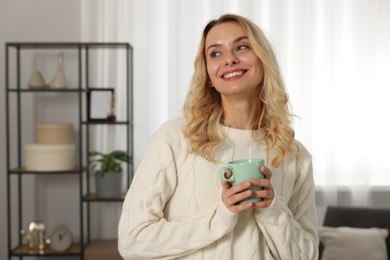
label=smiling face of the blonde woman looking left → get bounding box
[205,22,264,99]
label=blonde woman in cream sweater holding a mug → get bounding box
[118,14,318,260]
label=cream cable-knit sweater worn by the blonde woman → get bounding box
[118,118,318,260]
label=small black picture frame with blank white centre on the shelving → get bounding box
[87,88,115,121]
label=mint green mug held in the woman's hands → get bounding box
[218,158,264,204]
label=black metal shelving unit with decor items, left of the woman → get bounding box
[5,42,133,259]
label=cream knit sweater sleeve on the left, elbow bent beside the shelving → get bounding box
[118,127,238,259]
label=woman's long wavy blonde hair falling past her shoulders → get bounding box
[183,14,294,167]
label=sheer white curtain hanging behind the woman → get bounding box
[82,0,390,223]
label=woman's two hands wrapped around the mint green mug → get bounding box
[222,166,275,213]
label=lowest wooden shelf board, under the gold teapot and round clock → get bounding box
[12,244,81,256]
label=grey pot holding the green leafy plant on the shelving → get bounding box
[95,173,122,198]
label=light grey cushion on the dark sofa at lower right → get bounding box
[318,227,388,260]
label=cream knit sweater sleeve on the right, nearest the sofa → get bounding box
[255,143,318,259]
